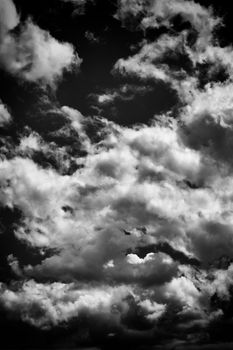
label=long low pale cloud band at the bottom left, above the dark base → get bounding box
[0,280,165,332]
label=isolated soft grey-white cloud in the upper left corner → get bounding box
[0,0,81,85]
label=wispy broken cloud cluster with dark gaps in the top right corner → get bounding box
[113,0,232,103]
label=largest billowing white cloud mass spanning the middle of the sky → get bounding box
[0,114,231,280]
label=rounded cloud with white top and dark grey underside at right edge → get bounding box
[182,83,232,166]
